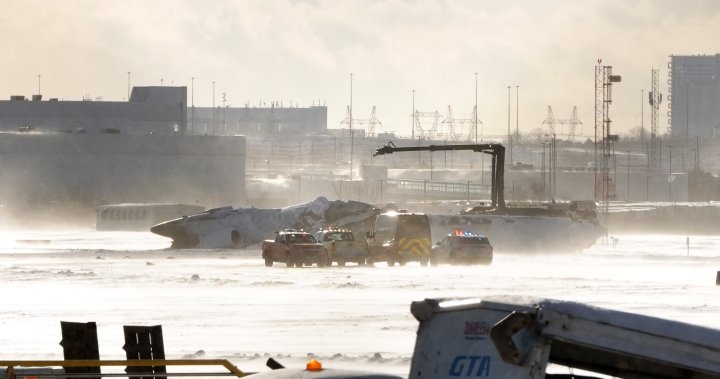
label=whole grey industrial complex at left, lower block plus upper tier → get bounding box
[0,86,327,224]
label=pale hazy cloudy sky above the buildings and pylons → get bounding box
[0,0,720,140]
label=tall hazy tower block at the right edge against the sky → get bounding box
[668,54,720,138]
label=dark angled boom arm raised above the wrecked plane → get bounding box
[373,141,505,209]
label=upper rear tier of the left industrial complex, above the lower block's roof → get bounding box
[0,86,327,136]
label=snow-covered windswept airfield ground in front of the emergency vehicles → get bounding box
[0,231,720,376]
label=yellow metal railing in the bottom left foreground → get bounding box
[0,359,253,379]
